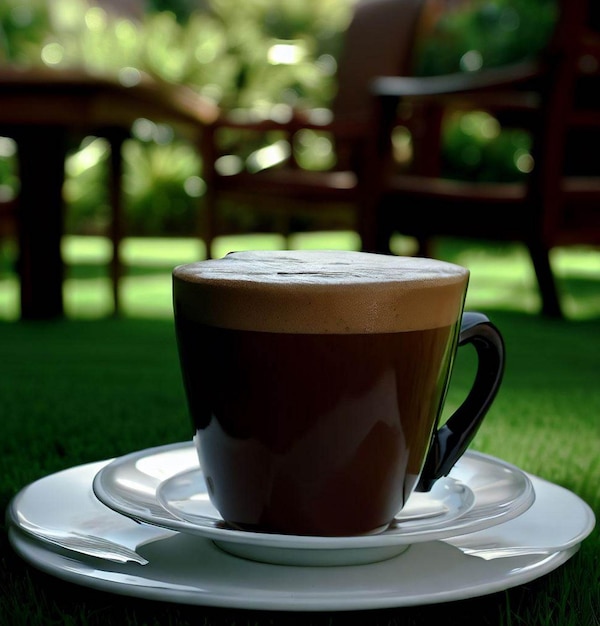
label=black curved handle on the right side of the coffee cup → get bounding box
[416,313,504,491]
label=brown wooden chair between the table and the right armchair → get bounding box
[201,0,423,255]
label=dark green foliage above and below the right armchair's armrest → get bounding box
[414,0,557,182]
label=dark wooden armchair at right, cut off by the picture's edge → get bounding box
[365,0,600,317]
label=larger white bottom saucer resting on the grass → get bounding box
[7,462,594,611]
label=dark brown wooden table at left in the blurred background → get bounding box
[0,67,218,319]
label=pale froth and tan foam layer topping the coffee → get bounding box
[173,250,469,334]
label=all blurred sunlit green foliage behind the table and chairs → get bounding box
[0,0,555,234]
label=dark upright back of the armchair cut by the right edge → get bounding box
[529,0,600,239]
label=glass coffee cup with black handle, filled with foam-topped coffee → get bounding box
[173,250,504,536]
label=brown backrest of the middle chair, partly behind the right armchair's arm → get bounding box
[332,0,425,121]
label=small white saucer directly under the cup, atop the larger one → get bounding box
[93,442,535,565]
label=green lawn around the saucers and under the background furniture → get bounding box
[0,234,600,626]
